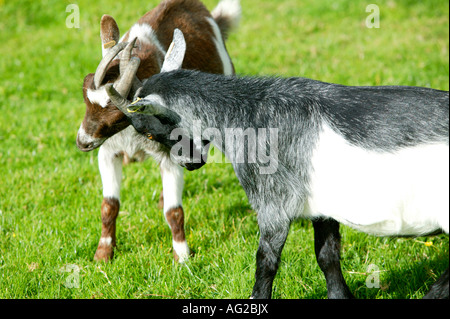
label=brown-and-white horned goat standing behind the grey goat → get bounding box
[77,0,241,262]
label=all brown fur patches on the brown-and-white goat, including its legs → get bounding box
[77,0,237,261]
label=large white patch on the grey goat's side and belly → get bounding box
[304,125,449,236]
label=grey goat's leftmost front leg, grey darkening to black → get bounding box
[251,218,290,299]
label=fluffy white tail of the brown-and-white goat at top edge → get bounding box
[211,0,241,40]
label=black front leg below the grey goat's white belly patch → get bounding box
[313,219,354,299]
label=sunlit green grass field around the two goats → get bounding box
[0,0,449,299]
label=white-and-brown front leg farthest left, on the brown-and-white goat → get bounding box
[94,146,123,261]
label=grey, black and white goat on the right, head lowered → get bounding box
[106,31,449,298]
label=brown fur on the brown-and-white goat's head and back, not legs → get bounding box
[83,0,234,139]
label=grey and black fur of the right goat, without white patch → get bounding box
[114,70,449,298]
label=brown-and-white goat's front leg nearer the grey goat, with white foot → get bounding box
[160,157,191,263]
